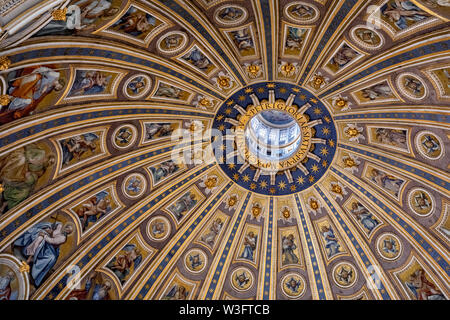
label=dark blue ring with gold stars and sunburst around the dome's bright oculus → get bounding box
[212,82,337,195]
